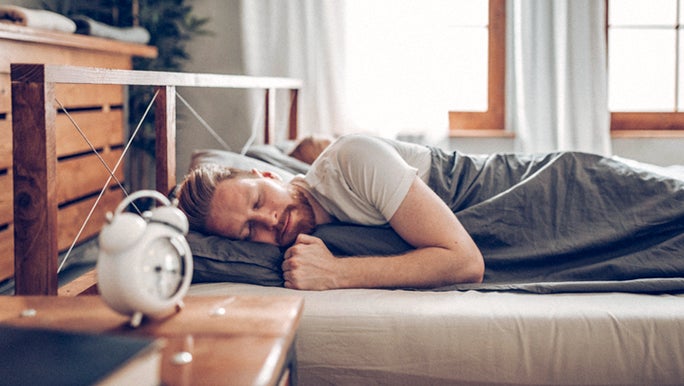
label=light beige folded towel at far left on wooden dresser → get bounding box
[0,5,76,33]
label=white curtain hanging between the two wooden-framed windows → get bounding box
[506,0,611,155]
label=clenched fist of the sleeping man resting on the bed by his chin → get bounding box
[282,234,340,290]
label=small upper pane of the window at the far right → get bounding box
[608,0,677,26]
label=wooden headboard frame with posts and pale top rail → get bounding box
[11,64,302,295]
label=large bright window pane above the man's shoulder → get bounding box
[345,0,489,129]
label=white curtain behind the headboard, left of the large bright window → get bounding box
[240,0,345,139]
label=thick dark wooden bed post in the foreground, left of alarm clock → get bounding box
[11,64,59,295]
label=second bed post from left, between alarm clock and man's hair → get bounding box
[154,86,176,194]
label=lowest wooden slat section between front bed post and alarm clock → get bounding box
[57,189,123,251]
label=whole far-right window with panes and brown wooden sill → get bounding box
[606,0,684,133]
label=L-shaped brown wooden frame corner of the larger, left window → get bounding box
[449,0,506,136]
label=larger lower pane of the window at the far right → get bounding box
[608,29,675,111]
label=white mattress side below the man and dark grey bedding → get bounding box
[190,283,684,386]
